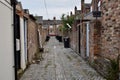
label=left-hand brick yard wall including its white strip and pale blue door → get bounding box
[16,2,39,66]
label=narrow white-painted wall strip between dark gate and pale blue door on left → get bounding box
[20,17,26,70]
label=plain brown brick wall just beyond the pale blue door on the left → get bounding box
[28,19,39,63]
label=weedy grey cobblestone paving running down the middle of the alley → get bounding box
[20,37,105,80]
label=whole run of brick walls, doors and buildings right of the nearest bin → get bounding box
[71,0,120,77]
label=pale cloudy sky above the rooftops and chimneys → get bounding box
[18,0,91,19]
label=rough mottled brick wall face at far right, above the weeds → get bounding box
[101,0,120,58]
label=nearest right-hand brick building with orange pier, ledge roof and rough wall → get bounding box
[84,0,120,76]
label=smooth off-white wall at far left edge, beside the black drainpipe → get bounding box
[0,0,15,80]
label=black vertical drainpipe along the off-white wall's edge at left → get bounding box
[12,0,18,80]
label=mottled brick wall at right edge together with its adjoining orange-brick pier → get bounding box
[90,0,120,76]
